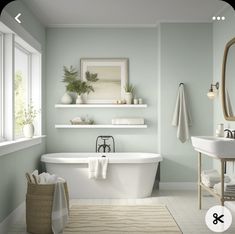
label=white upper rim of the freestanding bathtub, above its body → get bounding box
[40,152,163,164]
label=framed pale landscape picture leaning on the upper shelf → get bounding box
[81,58,128,103]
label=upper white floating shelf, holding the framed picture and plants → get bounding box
[55,104,147,108]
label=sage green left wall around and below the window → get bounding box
[0,1,45,223]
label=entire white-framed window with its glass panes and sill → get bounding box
[0,21,42,156]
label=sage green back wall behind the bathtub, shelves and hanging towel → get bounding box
[46,23,213,182]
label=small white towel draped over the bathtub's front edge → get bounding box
[88,157,108,179]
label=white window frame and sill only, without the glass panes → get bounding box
[0,19,45,156]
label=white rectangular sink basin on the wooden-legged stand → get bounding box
[191,136,235,158]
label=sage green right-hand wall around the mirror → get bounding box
[213,6,235,177]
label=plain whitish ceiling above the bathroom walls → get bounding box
[22,0,229,27]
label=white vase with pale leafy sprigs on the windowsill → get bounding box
[17,103,38,138]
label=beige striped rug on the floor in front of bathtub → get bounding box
[64,205,182,234]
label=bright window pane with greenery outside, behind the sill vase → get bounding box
[14,46,29,138]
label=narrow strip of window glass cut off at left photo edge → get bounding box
[0,32,3,142]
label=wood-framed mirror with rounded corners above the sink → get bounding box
[222,38,235,121]
